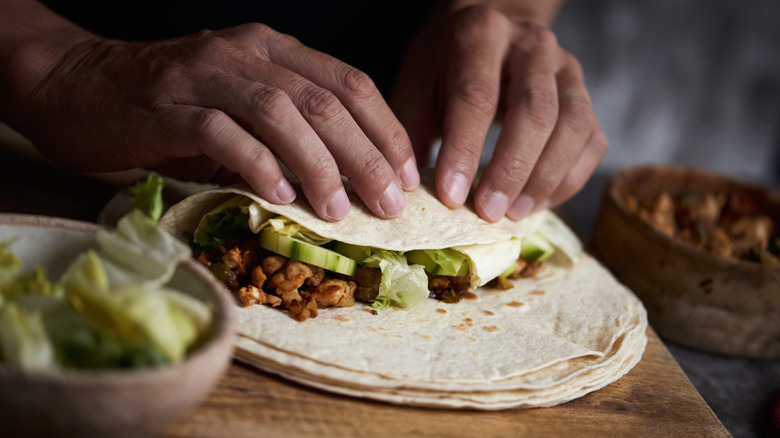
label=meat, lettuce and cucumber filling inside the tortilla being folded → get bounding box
[190,195,554,321]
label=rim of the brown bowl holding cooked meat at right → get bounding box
[607,164,780,272]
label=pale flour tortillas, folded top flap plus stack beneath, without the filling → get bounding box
[161,179,647,409]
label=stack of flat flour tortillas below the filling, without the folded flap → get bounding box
[232,252,647,409]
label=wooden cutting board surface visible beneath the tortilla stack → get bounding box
[162,329,731,438]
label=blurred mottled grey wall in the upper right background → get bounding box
[554,0,780,184]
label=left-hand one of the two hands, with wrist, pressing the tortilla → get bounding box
[6,24,419,220]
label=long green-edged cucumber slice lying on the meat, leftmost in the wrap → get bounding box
[259,229,357,276]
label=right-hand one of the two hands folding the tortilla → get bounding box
[391,6,607,222]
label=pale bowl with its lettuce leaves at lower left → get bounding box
[0,178,234,437]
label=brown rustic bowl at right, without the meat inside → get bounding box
[592,165,780,358]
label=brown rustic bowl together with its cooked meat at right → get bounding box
[592,165,780,358]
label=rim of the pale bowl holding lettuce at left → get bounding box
[0,213,236,383]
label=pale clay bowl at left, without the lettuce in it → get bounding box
[0,214,235,437]
